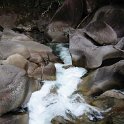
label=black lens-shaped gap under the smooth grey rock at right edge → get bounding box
[100,57,124,67]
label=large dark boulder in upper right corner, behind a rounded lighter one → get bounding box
[91,6,124,37]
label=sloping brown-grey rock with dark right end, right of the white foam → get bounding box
[80,60,124,96]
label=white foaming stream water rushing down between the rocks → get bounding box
[28,44,102,124]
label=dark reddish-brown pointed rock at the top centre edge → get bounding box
[52,0,86,27]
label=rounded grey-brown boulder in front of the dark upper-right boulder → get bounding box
[85,21,117,45]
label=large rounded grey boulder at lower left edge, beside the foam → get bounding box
[0,65,32,115]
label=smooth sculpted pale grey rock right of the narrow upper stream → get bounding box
[69,30,124,69]
